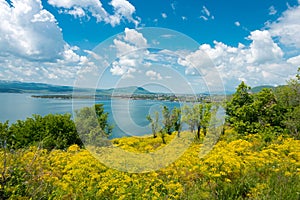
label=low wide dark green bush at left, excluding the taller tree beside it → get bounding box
[7,114,82,150]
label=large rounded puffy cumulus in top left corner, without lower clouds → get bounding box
[0,0,65,61]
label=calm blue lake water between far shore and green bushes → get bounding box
[0,93,180,137]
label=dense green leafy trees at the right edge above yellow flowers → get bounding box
[226,68,300,139]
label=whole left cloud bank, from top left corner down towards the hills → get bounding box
[0,0,87,84]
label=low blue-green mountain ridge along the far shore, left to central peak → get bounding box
[0,80,154,96]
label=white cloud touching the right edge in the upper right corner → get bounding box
[267,2,300,48]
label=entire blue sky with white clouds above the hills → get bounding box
[0,0,300,92]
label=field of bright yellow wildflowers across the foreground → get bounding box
[0,130,300,199]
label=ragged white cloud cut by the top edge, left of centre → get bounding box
[48,0,139,27]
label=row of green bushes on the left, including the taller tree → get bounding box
[0,104,112,150]
